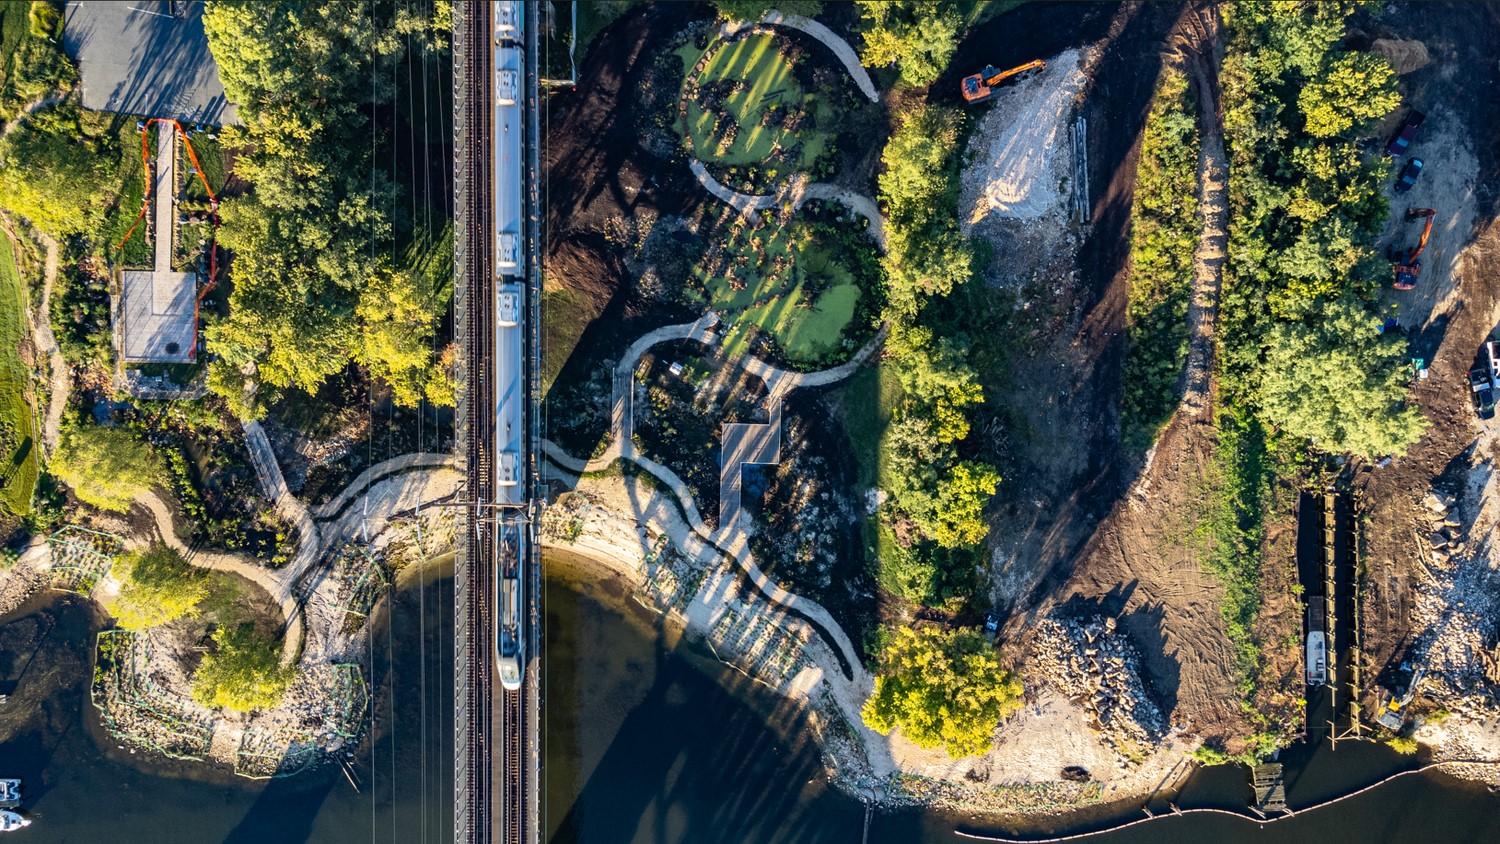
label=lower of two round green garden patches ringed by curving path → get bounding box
[699,226,860,363]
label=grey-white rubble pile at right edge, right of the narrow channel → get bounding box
[1412,490,1500,714]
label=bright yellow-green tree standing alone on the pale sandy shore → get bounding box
[861,628,1023,759]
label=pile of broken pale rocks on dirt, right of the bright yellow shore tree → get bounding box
[1028,616,1167,765]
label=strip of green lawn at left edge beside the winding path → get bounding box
[0,235,39,516]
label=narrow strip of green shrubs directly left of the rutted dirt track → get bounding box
[1121,66,1202,448]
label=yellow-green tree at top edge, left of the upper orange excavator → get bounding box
[860,0,962,87]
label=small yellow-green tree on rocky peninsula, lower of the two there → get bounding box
[192,622,291,712]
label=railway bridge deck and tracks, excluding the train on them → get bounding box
[455,1,542,844]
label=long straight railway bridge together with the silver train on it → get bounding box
[453,0,542,844]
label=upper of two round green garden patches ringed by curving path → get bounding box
[680,34,834,168]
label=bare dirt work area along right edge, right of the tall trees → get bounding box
[1352,3,1500,710]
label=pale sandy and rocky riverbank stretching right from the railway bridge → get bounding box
[542,472,1197,826]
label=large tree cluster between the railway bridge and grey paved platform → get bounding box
[204,0,450,417]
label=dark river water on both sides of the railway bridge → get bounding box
[0,558,1500,844]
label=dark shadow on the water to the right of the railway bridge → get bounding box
[549,620,920,844]
